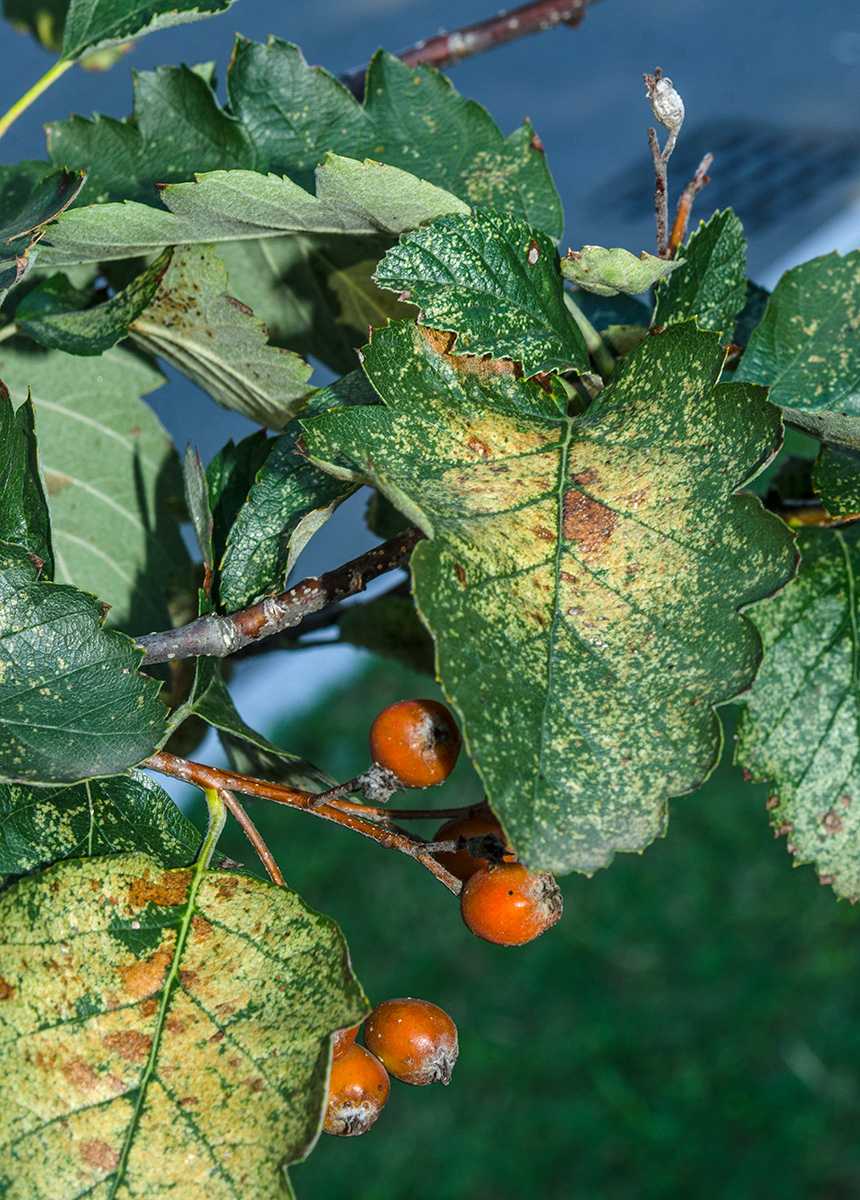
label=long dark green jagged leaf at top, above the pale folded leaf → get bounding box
[48,37,563,239]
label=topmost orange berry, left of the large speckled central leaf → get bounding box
[371,700,462,787]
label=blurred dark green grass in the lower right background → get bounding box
[211,658,860,1200]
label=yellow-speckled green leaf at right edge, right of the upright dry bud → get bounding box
[735,250,860,417]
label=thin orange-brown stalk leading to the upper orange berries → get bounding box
[142,750,462,895]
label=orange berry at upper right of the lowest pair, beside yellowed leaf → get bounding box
[365,996,459,1087]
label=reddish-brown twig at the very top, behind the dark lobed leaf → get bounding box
[341,0,597,100]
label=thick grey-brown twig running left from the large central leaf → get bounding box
[134,529,423,666]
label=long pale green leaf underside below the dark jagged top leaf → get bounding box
[40,155,465,266]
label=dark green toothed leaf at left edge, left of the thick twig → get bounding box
[0,546,167,784]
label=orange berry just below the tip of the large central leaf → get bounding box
[459,863,561,946]
